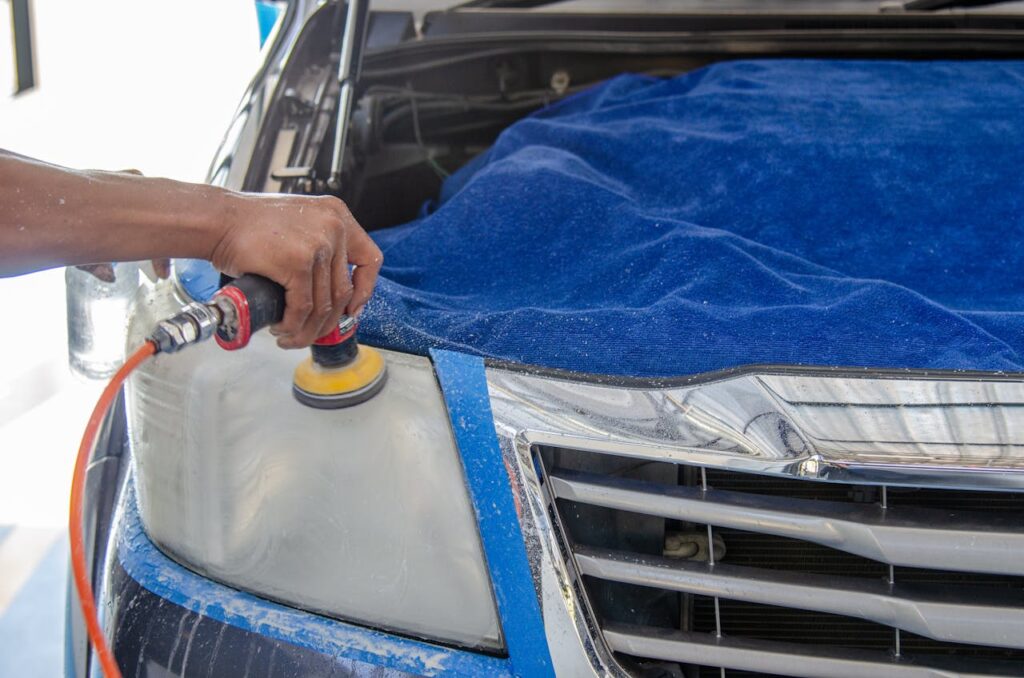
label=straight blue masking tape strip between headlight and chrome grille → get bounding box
[430,350,555,678]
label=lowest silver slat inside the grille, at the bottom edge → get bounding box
[604,626,1020,678]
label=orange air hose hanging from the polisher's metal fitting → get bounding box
[68,341,157,678]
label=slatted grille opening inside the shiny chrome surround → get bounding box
[539,448,1024,677]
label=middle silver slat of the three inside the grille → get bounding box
[574,547,1024,648]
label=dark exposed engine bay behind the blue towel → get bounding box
[245,4,1024,230]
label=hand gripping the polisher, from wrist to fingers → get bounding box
[210,194,384,348]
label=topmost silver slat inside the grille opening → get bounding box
[549,471,1024,576]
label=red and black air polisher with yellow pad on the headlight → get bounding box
[150,273,387,410]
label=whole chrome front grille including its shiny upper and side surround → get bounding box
[487,365,1024,678]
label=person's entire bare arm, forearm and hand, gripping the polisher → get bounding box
[0,151,383,348]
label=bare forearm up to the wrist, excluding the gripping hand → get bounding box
[0,150,230,276]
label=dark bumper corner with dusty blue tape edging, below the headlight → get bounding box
[101,478,511,678]
